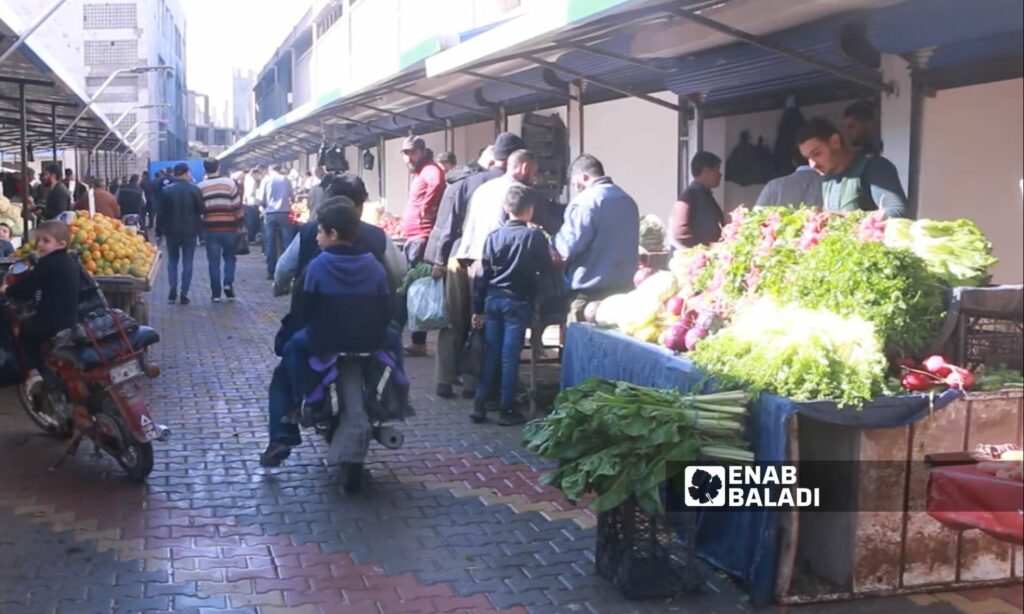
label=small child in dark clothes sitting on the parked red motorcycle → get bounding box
[4,221,81,397]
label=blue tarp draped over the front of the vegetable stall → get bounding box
[561,324,961,606]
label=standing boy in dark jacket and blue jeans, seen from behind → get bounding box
[470,185,553,427]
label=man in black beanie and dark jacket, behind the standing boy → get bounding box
[424,137,523,399]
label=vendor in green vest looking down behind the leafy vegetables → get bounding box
[797,118,907,218]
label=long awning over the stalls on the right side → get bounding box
[214,0,1024,167]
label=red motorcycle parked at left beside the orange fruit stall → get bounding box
[0,257,170,480]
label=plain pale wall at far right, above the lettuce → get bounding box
[919,79,1024,283]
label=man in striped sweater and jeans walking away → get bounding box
[199,158,244,303]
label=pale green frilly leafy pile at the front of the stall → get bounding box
[691,298,888,405]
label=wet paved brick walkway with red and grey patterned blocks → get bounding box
[0,246,1021,614]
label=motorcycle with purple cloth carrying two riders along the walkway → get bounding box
[295,351,414,492]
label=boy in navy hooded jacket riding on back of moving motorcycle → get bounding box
[260,206,391,488]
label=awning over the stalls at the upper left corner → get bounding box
[0,2,128,154]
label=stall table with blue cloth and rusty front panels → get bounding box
[561,324,1024,606]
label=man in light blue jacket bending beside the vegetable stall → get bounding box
[553,154,640,321]
